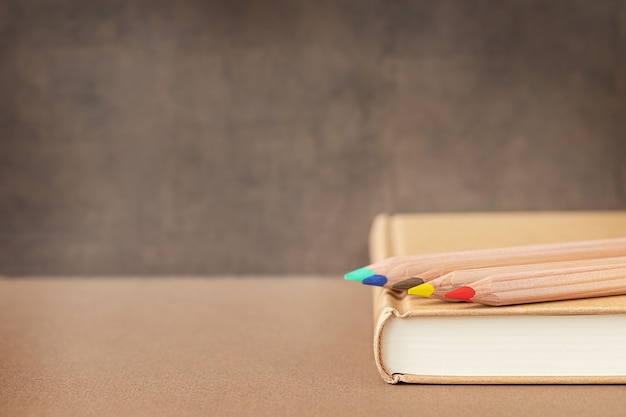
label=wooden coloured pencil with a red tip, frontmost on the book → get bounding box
[445,263,626,306]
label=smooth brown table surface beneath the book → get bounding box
[0,277,626,417]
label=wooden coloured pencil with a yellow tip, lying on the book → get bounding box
[408,256,626,298]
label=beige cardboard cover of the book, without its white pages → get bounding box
[369,211,626,384]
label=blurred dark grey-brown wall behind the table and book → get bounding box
[0,0,626,275]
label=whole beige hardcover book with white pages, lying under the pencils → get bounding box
[369,211,626,384]
